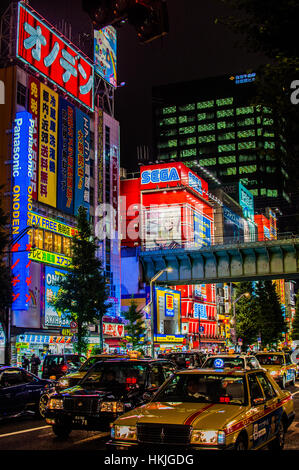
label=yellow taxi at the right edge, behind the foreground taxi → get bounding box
[255,351,297,389]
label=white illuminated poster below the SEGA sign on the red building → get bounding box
[145,205,182,248]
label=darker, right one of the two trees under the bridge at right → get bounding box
[255,280,287,347]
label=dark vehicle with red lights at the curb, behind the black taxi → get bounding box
[42,354,86,380]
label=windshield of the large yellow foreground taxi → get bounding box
[153,374,247,405]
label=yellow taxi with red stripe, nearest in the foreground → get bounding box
[107,369,295,450]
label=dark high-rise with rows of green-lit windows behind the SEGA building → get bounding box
[152,73,290,210]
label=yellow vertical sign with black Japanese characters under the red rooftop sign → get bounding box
[38,83,58,207]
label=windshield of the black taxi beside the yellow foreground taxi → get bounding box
[80,362,146,391]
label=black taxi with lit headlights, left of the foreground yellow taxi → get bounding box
[45,359,176,437]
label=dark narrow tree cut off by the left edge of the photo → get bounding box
[0,196,12,364]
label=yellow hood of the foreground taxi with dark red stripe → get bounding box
[115,402,246,429]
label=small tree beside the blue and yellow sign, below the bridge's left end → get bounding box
[123,298,146,350]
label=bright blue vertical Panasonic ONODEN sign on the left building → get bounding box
[11,111,34,310]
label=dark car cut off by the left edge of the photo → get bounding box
[0,366,55,420]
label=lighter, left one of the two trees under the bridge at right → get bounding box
[234,282,258,349]
